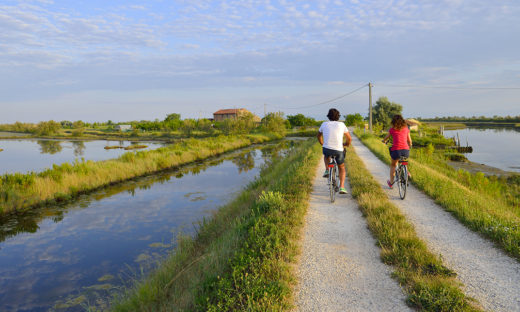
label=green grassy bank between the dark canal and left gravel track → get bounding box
[113,141,320,311]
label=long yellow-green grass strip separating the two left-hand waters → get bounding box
[0,134,280,215]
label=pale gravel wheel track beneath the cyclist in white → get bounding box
[296,163,412,311]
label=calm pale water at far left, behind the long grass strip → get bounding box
[0,139,167,174]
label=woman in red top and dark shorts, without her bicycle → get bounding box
[383,114,412,188]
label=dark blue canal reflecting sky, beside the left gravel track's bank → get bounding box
[0,142,294,311]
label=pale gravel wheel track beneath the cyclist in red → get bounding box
[352,136,520,311]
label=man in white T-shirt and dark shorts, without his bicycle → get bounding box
[318,108,352,194]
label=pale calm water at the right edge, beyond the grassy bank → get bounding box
[444,128,520,172]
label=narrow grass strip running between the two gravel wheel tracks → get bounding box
[346,147,478,311]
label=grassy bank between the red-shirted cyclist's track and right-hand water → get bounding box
[358,129,520,260]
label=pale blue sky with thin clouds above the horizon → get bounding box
[0,0,520,123]
